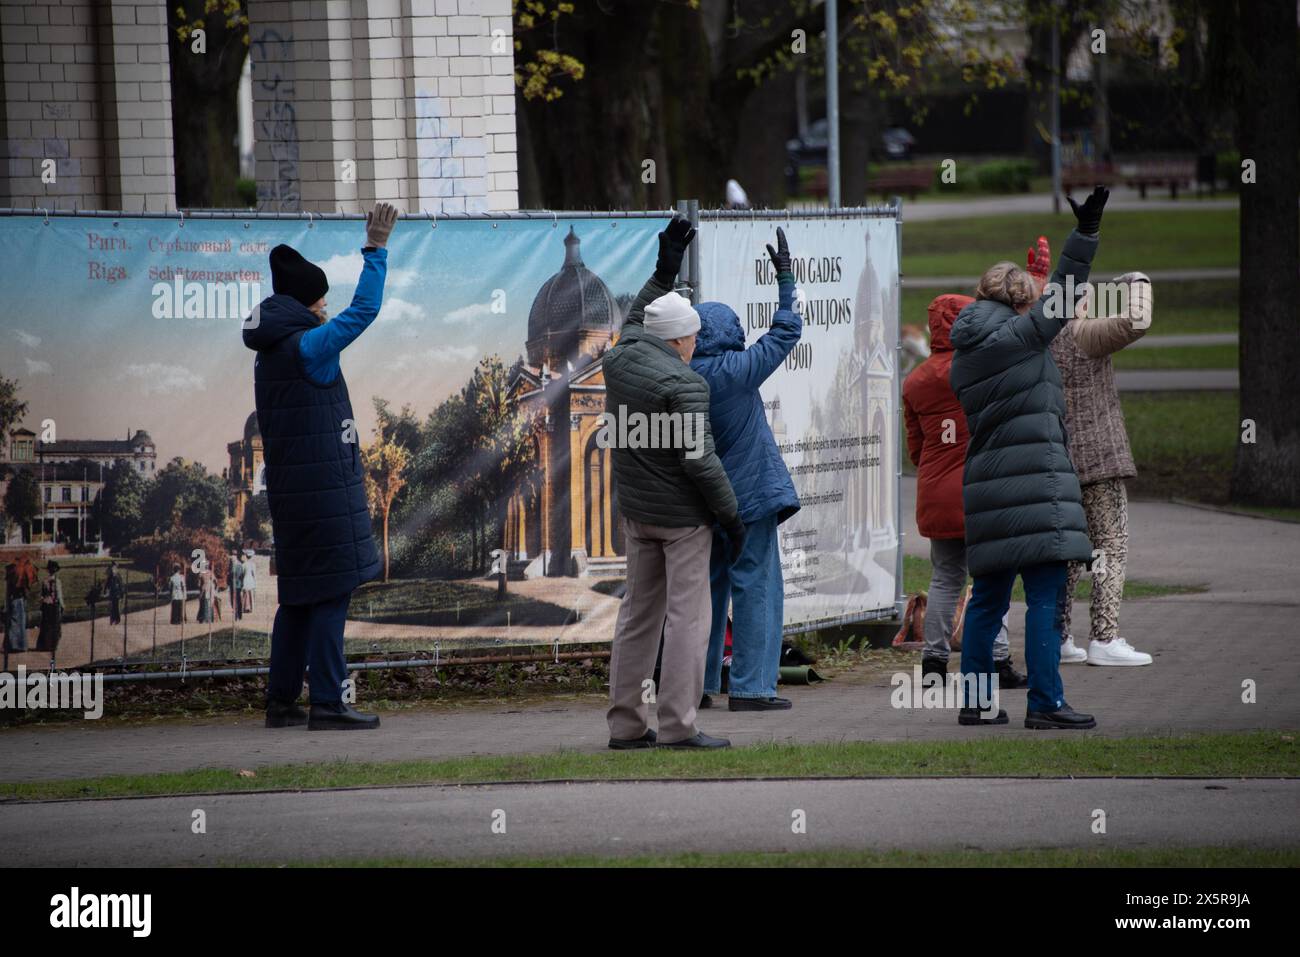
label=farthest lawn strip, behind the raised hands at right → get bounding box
[902,209,1239,273]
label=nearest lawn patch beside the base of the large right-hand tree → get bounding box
[1119,393,1240,505]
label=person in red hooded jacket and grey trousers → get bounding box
[902,294,1028,689]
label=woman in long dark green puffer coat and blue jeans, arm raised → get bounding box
[949,186,1109,728]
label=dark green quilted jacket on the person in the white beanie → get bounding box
[602,278,738,528]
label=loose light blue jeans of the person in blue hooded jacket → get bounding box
[705,515,785,698]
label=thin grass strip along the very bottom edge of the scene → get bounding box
[286,845,1300,869]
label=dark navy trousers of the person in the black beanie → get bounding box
[267,592,352,705]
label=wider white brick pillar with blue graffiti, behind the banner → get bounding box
[250,0,519,212]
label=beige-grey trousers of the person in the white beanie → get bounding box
[607,519,714,744]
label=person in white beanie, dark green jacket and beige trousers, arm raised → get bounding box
[602,217,745,750]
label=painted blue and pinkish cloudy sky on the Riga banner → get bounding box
[0,216,666,473]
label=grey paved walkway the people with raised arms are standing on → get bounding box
[0,479,1300,781]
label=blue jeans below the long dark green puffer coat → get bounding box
[962,562,1066,711]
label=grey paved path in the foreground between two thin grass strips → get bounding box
[0,778,1300,867]
